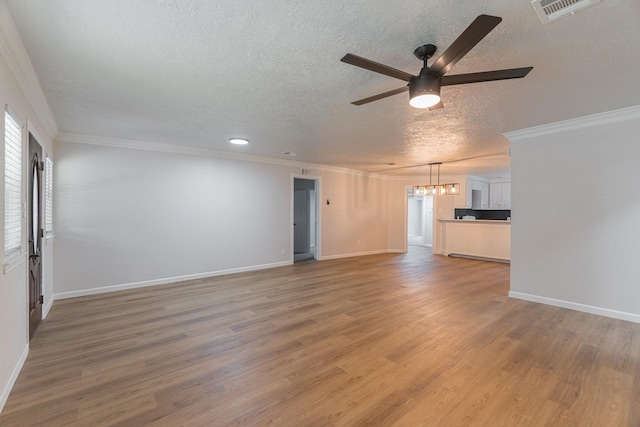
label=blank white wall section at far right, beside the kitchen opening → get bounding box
[507,107,640,322]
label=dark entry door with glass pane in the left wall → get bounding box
[28,134,43,338]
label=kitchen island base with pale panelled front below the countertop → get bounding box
[438,219,511,261]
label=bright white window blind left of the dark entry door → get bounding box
[4,106,23,260]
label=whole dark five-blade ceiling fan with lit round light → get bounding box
[341,15,533,110]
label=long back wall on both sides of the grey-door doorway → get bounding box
[54,138,396,297]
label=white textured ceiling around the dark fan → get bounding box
[6,0,640,177]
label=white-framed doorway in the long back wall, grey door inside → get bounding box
[293,177,319,262]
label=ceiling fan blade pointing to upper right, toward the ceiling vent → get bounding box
[429,15,502,76]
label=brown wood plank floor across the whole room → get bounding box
[0,247,640,427]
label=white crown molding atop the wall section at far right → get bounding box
[503,105,640,142]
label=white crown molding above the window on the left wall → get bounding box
[0,2,58,139]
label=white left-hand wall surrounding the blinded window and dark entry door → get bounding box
[0,2,57,410]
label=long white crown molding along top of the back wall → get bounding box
[55,132,389,179]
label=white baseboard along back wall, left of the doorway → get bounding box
[53,261,291,300]
